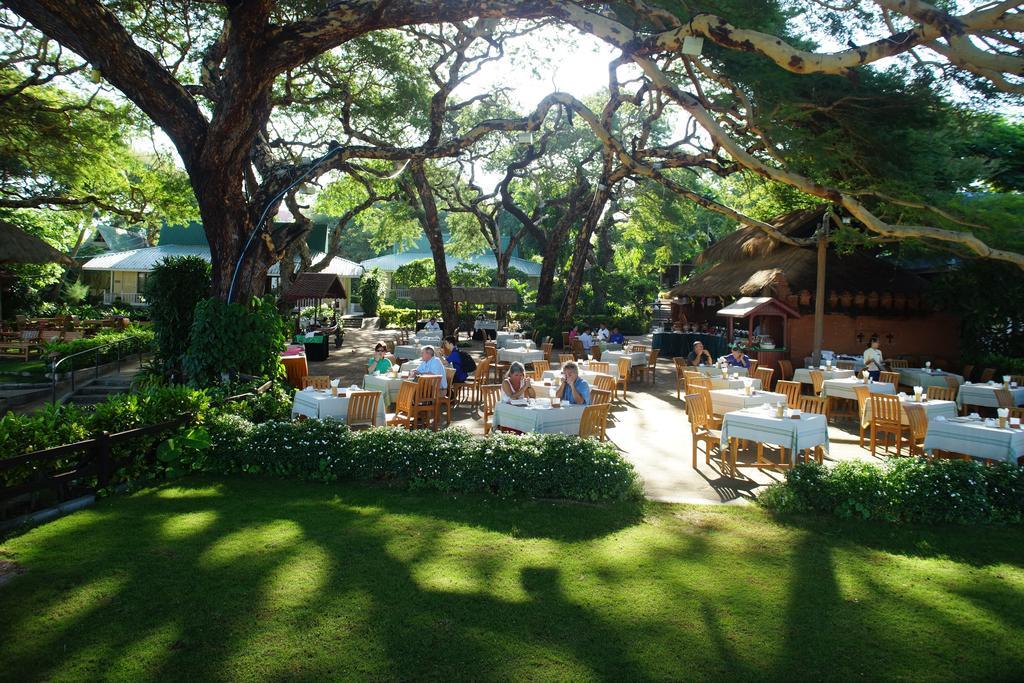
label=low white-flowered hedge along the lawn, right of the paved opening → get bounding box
[758,458,1024,524]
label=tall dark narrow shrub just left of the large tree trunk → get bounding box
[144,256,211,375]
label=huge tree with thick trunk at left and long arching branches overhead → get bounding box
[6,0,1024,318]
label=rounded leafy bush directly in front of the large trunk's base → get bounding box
[182,297,288,386]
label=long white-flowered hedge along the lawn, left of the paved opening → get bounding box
[191,416,640,501]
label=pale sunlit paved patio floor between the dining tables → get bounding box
[309,330,878,504]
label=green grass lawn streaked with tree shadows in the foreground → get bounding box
[0,478,1024,681]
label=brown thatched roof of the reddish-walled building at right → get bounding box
[671,208,926,297]
